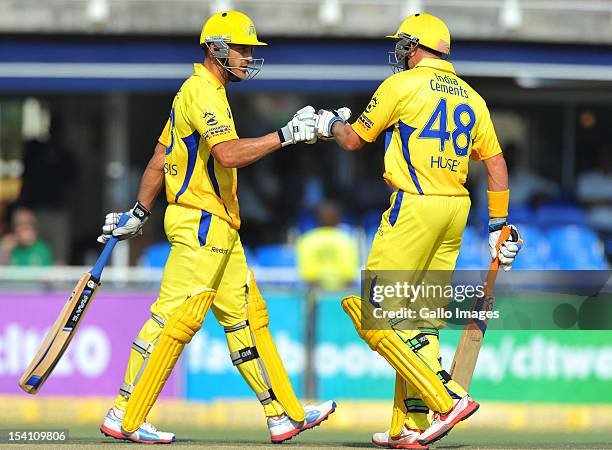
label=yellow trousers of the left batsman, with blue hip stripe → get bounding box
[115,204,284,416]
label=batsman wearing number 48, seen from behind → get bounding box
[317,14,522,448]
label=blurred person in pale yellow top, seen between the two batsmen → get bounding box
[297,203,359,290]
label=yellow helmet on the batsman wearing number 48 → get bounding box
[386,13,450,55]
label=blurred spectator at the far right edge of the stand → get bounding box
[577,144,612,235]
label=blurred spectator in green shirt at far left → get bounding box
[0,208,53,266]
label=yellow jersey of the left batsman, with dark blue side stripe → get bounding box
[159,64,240,229]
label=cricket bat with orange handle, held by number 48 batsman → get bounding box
[450,227,510,391]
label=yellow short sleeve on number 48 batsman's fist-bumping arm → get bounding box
[352,79,400,142]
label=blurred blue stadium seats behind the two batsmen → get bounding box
[140,205,612,270]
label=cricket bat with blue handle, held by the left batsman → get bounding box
[19,214,128,395]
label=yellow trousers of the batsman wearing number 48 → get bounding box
[366,191,470,430]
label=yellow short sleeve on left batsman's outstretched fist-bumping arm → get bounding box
[189,98,238,148]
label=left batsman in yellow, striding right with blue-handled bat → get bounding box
[99,11,336,443]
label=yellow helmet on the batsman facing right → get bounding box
[200,11,268,45]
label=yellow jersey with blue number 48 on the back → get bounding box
[352,58,501,196]
